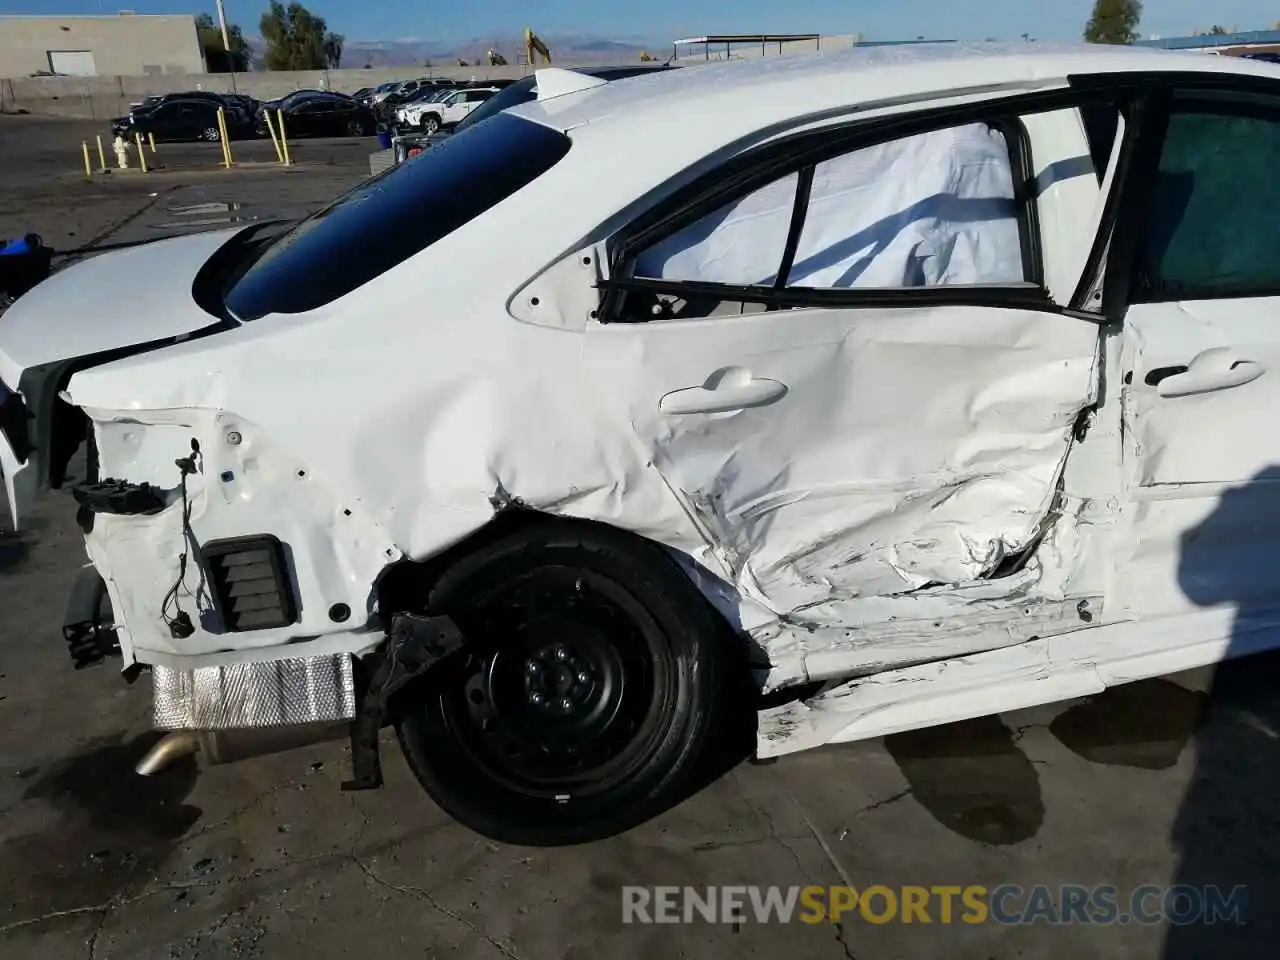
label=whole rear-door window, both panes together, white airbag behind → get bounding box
[635,123,1028,289]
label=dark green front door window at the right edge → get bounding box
[1139,106,1280,298]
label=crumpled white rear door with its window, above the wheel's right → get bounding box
[586,111,1100,618]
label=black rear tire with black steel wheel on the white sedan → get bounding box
[396,524,736,846]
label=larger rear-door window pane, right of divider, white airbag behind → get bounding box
[787,123,1025,289]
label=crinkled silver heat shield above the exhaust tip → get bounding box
[151,653,356,730]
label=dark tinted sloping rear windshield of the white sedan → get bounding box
[223,114,570,320]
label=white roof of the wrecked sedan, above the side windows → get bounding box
[512,41,1275,136]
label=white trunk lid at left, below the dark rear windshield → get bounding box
[0,228,242,387]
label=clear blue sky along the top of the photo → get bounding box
[0,0,1280,42]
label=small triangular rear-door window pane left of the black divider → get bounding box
[635,174,799,284]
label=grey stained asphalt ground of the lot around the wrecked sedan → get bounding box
[0,116,1280,960]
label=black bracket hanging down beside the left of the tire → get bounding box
[342,613,462,790]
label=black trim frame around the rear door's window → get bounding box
[596,88,1085,323]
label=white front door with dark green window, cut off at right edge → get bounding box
[1107,86,1280,616]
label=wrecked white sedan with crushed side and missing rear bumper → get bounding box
[0,44,1280,844]
